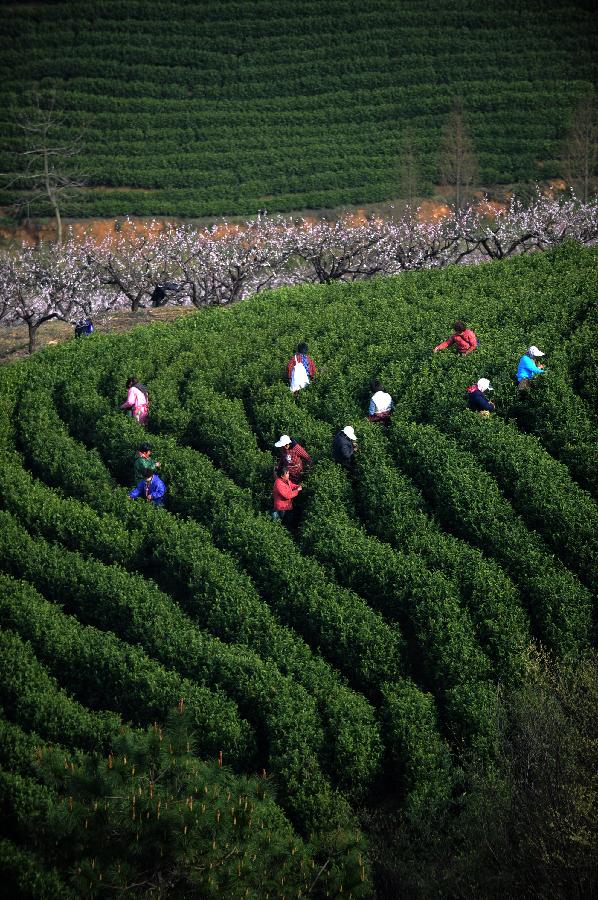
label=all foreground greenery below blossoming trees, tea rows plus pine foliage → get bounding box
[0,242,598,900]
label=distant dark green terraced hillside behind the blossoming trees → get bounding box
[0,0,598,217]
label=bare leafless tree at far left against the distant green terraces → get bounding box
[9,94,87,243]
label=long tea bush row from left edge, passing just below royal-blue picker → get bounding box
[0,441,380,785]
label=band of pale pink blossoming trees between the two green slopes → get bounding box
[0,193,598,349]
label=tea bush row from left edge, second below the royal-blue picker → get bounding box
[0,512,346,828]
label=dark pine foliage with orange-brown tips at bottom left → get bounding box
[0,714,366,897]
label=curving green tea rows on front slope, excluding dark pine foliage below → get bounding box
[0,245,596,895]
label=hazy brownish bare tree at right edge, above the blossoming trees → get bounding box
[564,91,598,203]
